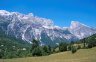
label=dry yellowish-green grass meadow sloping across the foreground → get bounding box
[0,47,96,62]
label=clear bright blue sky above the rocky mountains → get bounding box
[0,0,96,27]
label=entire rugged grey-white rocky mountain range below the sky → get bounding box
[0,10,96,45]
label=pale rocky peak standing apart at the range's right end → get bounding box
[69,21,96,39]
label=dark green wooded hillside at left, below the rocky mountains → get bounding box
[0,32,30,59]
